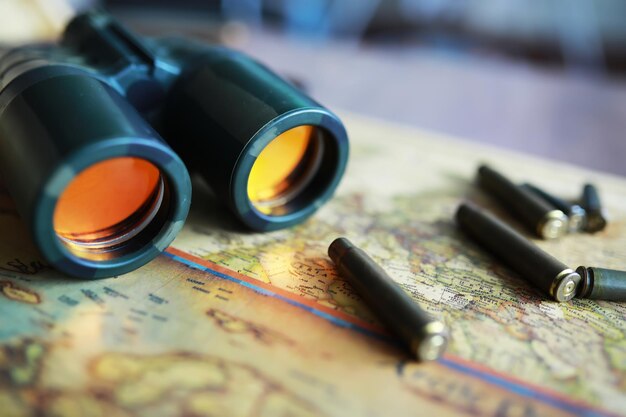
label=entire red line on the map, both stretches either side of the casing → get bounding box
[166,246,620,417]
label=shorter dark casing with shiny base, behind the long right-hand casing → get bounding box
[478,165,567,239]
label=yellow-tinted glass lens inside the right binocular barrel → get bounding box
[248,125,323,214]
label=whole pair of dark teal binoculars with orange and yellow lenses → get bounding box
[0,12,348,278]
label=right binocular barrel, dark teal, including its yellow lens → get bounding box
[158,39,348,231]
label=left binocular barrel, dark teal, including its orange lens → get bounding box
[0,67,191,278]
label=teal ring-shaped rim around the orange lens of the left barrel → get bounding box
[32,137,191,279]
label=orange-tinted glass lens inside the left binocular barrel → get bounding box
[54,157,163,250]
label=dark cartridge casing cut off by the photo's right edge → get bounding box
[576,266,626,301]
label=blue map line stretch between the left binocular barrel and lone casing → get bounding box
[163,252,391,342]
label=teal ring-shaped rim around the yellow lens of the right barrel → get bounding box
[229,108,349,231]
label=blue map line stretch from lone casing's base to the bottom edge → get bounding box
[438,358,612,417]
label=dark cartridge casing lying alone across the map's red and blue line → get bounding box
[328,237,449,361]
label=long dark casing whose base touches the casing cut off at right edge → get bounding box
[456,204,580,302]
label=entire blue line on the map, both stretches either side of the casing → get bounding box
[164,252,612,417]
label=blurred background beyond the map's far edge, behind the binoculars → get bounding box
[0,0,626,176]
